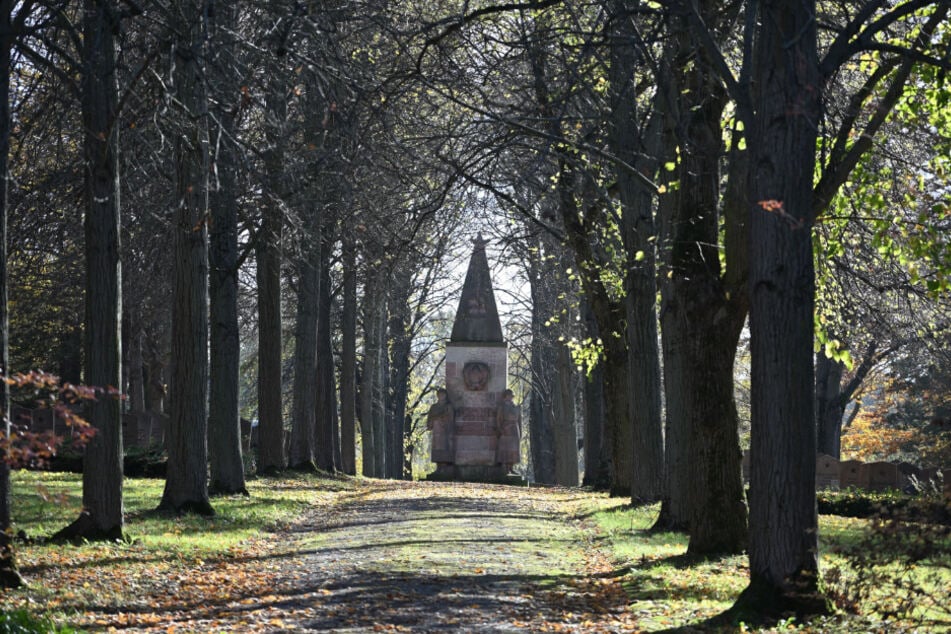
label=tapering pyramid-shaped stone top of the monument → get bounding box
[449,234,505,343]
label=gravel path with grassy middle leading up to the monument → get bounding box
[267,482,628,632]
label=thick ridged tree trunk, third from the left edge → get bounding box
[159,0,214,515]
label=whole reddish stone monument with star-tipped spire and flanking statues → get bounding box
[429,235,520,482]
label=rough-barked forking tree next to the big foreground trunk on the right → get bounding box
[655,2,748,555]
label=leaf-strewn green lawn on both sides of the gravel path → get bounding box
[7,471,951,632]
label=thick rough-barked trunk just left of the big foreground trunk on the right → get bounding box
[662,9,747,555]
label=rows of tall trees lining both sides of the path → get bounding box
[0,0,951,608]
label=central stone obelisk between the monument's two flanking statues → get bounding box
[440,235,508,481]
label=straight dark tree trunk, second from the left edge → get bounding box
[54,0,123,540]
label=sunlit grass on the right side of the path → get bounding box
[594,505,951,632]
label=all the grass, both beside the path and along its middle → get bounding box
[7,471,951,632]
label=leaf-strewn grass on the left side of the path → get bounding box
[0,471,354,627]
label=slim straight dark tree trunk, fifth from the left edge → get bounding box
[256,67,287,473]
